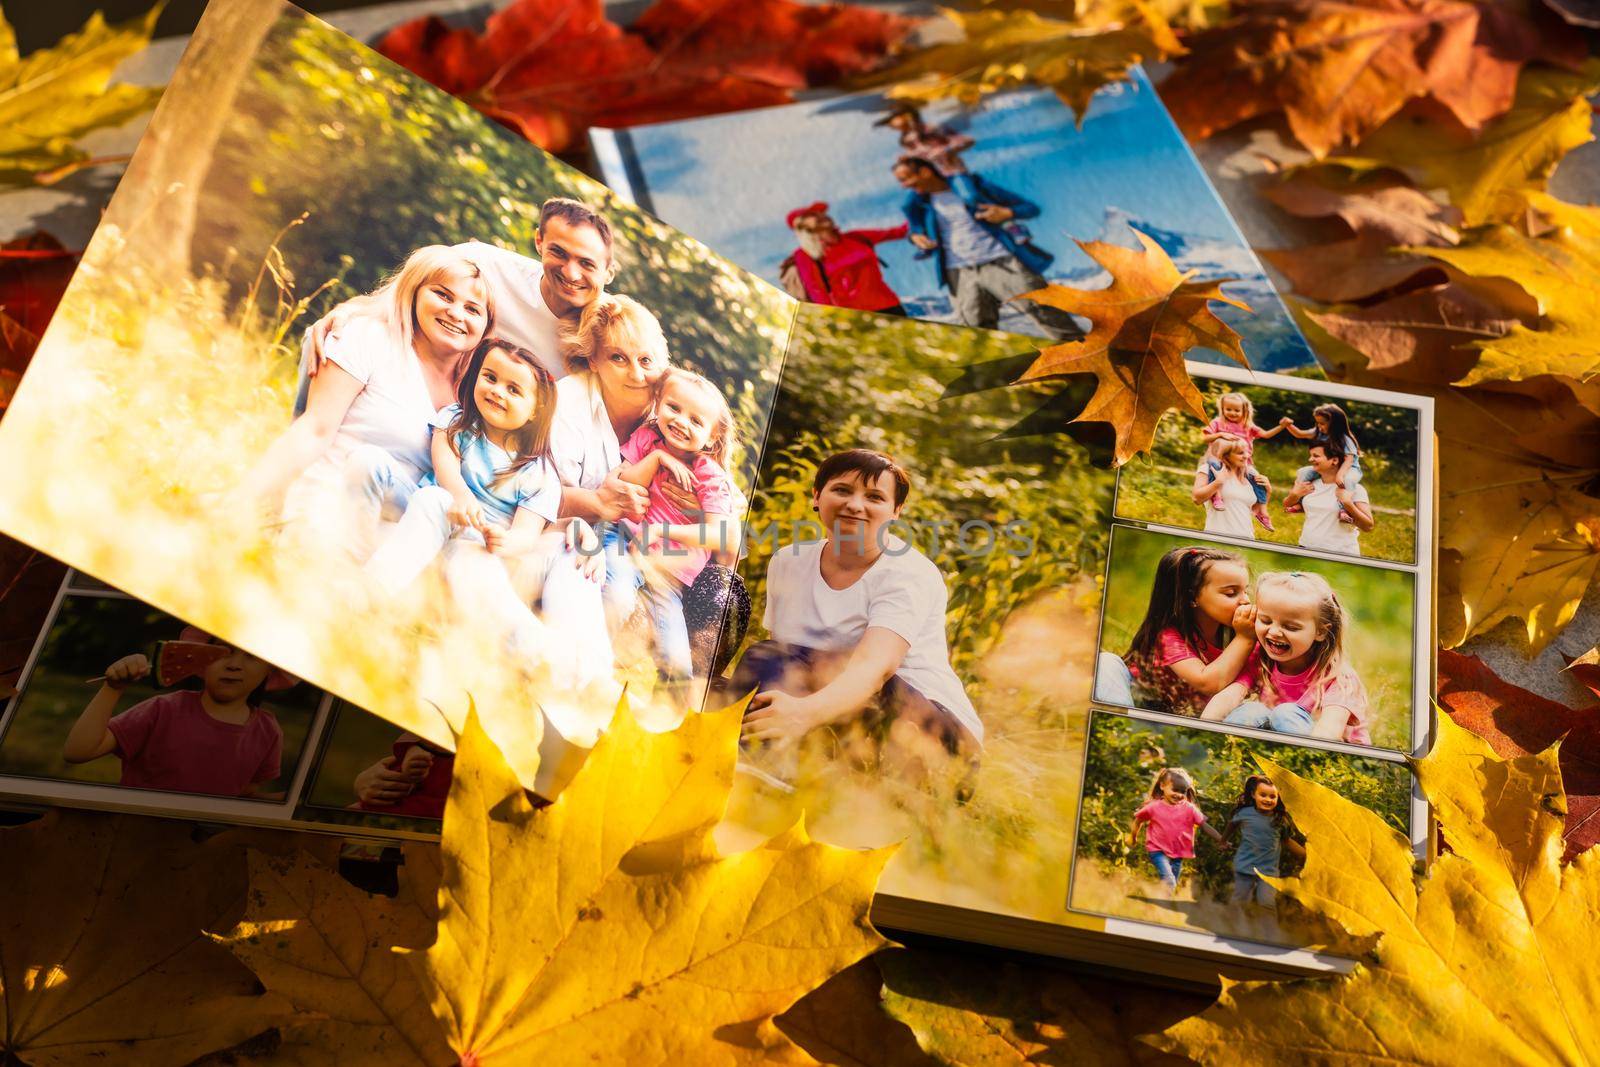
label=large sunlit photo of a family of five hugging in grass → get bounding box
[0,0,795,763]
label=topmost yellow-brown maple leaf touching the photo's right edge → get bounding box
[1328,59,1600,226]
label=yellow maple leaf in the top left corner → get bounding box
[0,3,165,176]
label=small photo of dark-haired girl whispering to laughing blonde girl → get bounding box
[1094,525,1426,750]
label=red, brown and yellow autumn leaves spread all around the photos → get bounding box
[0,0,1600,1067]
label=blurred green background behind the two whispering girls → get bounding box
[1101,526,1416,750]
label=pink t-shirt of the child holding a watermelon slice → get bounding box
[107,689,283,797]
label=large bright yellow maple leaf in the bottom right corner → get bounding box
[1155,717,1600,1067]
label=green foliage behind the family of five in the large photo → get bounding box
[194,14,792,485]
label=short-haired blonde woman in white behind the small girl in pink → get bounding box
[550,293,750,675]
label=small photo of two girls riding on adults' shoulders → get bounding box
[1117,379,1419,563]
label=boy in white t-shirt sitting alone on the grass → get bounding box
[733,448,984,780]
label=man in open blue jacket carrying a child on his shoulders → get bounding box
[894,155,1083,339]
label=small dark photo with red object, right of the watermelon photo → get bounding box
[294,701,456,833]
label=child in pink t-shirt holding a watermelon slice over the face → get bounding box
[62,625,296,797]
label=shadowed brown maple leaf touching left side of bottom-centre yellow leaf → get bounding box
[216,849,456,1067]
